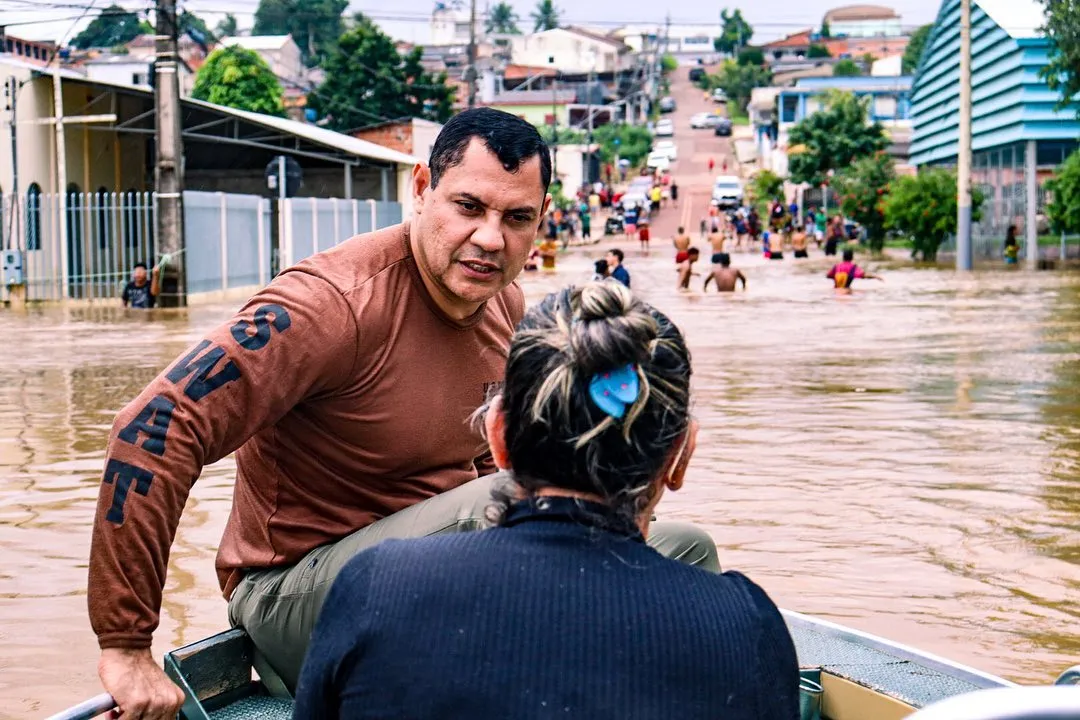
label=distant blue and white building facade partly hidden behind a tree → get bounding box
[777,76,914,128]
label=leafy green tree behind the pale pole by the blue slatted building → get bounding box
[885,169,983,262]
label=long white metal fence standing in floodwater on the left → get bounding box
[0,189,402,301]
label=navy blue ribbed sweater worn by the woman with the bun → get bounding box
[295,498,799,720]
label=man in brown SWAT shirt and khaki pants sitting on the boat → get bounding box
[89,109,717,720]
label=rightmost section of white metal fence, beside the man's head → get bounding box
[280,198,402,268]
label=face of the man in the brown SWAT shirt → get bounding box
[413,138,551,317]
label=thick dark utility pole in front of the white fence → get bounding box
[155,0,188,308]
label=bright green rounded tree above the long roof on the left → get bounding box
[191,45,285,117]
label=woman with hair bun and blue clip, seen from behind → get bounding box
[295,281,799,720]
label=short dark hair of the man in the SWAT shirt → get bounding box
[428,108,551,192]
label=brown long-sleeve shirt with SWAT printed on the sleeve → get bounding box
[89,226,524,649]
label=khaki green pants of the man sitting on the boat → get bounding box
[229,473,720,692]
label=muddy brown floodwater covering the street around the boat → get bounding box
[0,248,1080,718]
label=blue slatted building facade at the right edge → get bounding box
[910,0,1080,262]
